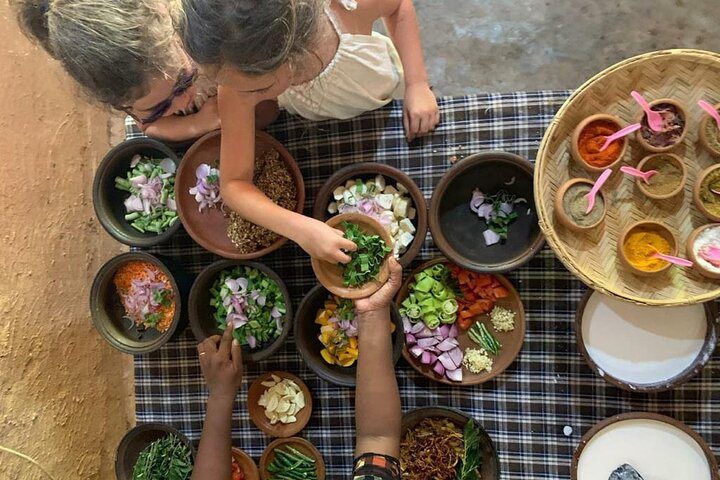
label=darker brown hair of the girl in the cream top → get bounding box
[180,0,326,74]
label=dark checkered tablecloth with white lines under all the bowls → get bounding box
[128,91,720,480]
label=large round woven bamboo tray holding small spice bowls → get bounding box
[534,50,720,306]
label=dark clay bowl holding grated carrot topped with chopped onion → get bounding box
[90,252,192,355]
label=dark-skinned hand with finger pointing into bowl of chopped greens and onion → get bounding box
[197,323,243,400]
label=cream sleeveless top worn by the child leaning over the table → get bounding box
[278,0,405,121]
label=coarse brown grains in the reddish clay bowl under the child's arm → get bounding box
[227,149,297,253]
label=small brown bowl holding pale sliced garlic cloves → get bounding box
[247,371,312,438]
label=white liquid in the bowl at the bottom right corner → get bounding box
[577,420,712,480]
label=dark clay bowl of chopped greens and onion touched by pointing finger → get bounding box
[188,260,293,363]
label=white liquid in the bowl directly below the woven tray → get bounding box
[582,293,707,385]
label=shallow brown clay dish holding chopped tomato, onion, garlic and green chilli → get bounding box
[395,257,525,386]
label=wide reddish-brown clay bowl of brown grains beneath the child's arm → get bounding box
[175,130,305,260]
